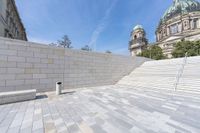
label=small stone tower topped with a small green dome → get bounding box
[129,25,148,56]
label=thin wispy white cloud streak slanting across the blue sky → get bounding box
[89,0,118,51]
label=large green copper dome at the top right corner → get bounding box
[162,0,200,21]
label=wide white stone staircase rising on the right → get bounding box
[117,56,200,94]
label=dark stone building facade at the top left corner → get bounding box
[0,0,27,41]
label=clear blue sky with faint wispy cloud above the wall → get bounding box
[16,0,173,55]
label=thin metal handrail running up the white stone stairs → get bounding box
[174,52,188,91]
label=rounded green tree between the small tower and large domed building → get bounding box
[138,45,166,60]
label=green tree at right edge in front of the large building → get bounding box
[172,41,200,58]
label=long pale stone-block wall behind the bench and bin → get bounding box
[0,38,150,92]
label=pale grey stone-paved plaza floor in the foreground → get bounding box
[0,85,200,133]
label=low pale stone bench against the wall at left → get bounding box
[0,90,36,105]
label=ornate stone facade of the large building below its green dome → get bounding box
[156,12,200,58]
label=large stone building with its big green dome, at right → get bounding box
[130,0,200,58]
